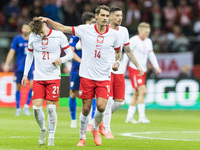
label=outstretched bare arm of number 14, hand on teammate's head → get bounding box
[39,17,72,34]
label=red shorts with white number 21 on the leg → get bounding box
[32,79,60,101]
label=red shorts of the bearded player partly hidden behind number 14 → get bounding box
[110,73,125,99]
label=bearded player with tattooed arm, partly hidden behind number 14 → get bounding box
[104,7,143,138]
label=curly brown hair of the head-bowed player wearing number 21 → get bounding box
[29,17,43,35]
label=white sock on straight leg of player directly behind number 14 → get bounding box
[103,97,113,133]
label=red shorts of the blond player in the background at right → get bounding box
[128,67,146,89]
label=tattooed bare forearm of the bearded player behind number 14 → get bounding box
[124,45,144,76]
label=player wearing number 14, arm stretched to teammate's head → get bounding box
[38,5,142,146]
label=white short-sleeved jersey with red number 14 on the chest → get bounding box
[72,24,120,81]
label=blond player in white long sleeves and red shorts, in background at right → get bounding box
[123,22,162,123]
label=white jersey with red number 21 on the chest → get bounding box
[28,29,71,80]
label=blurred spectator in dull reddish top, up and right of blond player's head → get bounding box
[163,0,177,32]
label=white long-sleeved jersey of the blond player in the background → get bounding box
[123,35,159,72]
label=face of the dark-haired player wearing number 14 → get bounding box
[96,9,109,25]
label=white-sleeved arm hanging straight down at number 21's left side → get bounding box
[21,49,33,87]
